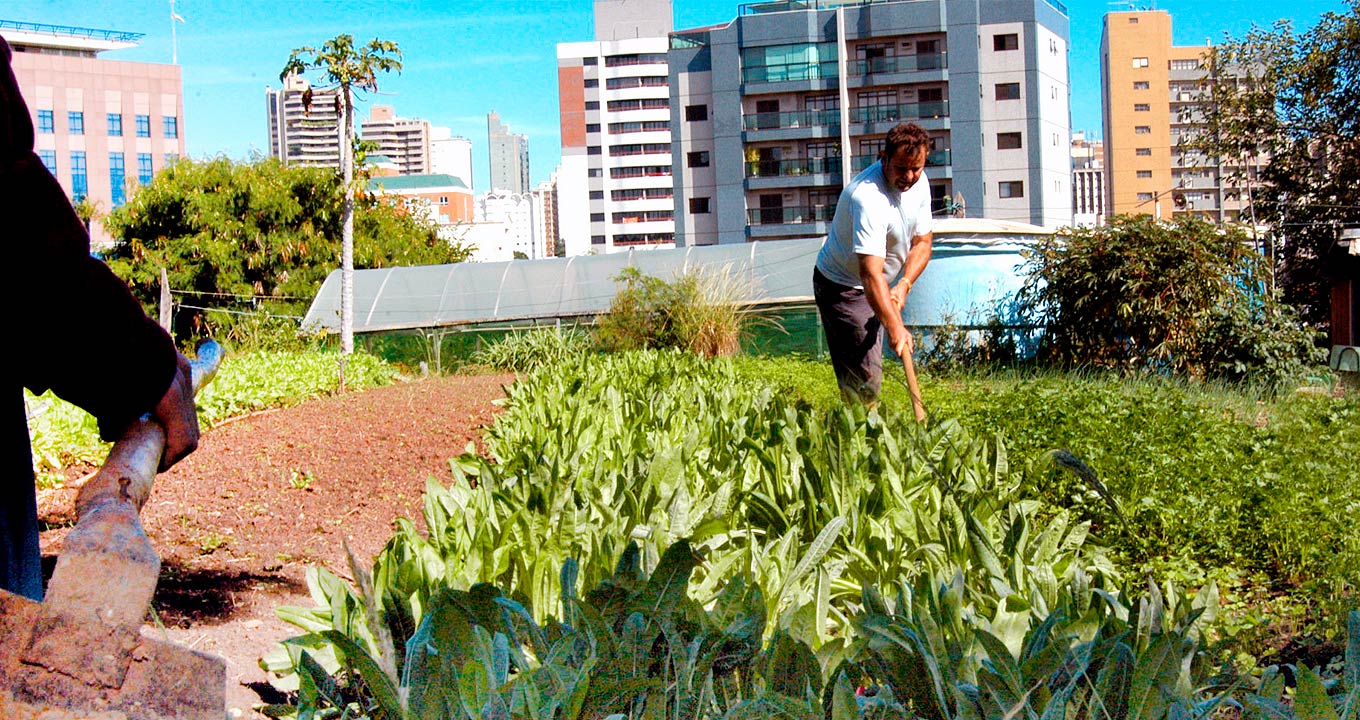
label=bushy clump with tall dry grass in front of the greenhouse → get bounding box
[596,267,756,358]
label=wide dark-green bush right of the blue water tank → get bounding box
[1020,215,1319,384]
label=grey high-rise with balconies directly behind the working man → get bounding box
[669,0,1072,245]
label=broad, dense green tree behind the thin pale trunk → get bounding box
[105,158,469,345]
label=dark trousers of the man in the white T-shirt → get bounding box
[812,269,883,402]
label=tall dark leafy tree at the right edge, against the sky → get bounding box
[1183,0,1360,327]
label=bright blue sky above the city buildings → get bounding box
[0,0,1348,192]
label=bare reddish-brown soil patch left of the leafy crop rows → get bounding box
[39,376,513,719]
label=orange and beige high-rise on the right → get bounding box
[1100,10,1262,222]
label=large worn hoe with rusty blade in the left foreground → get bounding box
[0,342,227,720]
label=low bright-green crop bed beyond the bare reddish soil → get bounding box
[24,350,396,474]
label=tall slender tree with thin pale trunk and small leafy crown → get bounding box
[279,35,401,355]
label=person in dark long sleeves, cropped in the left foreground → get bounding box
[0,38,199,600]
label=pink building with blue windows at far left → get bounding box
[0,20,185,246]
